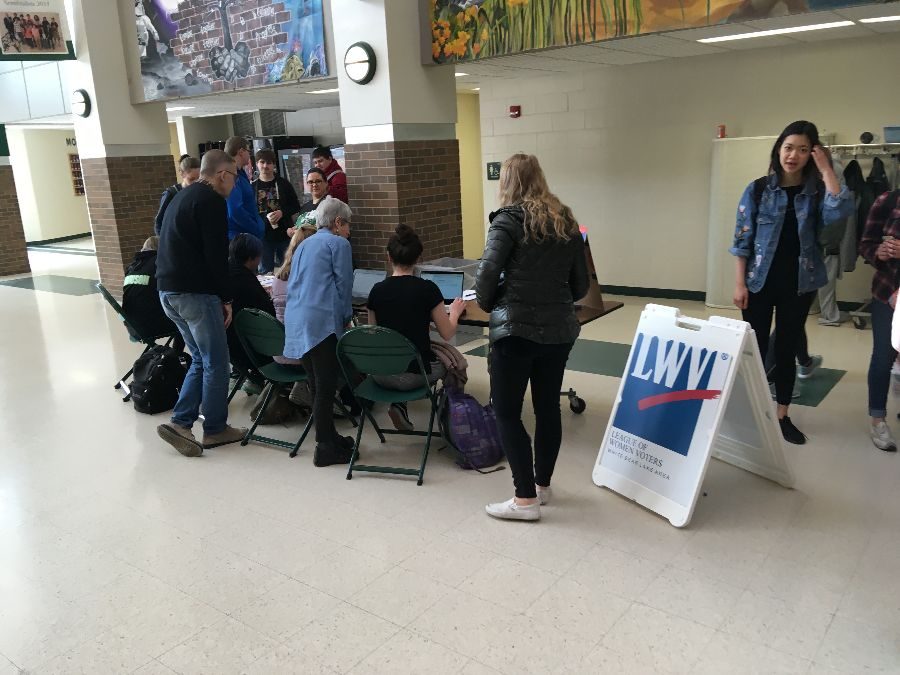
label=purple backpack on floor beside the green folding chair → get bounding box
[444,387,504,473]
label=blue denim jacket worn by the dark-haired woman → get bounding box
[728,174,854,293]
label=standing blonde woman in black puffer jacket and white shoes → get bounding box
[475,154,589,520]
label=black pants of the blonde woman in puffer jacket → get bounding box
[490,337,572,499]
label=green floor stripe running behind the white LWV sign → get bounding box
[466,340,847,408]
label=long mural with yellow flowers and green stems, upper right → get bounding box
[431,0,871,63]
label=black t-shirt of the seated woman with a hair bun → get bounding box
[366,275,444,372]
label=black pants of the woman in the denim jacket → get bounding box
[742,279,816,405]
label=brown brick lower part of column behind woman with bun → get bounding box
[344,139,463,269]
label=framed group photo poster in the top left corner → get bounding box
[0,0,71,58]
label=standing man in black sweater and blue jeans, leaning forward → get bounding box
[156,150,246,457]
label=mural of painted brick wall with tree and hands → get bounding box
[135,0,328,101]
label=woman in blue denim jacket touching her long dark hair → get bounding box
[729,121,853,445]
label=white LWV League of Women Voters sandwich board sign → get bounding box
[593,305,794,527]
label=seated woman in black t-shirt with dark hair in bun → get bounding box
[366,225,466,431]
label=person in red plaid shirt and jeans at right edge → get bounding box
[859,190,900,452]
